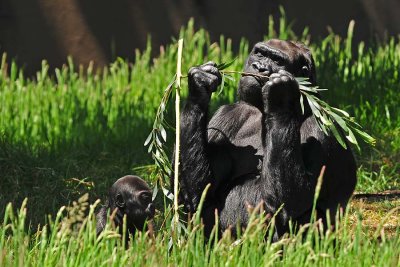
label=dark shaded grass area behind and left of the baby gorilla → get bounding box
[0,121,166,226]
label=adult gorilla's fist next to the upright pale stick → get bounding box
[188,61,222,105]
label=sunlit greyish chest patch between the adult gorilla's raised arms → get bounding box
[208,102,262,149]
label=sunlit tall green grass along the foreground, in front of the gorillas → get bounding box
[0,197,400,266]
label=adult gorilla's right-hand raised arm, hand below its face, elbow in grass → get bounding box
[262,71,316,234]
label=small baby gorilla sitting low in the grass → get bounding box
[96,175,155,240]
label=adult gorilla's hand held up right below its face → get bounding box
[262,70,301,116]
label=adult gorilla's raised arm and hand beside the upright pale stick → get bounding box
[175,62,221,212]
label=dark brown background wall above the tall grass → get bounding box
[0,0,400,73]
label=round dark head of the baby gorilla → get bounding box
[108,175,155,230]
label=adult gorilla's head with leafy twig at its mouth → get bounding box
[238,39,316,109]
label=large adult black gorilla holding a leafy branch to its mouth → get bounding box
[175,40,356,239]
